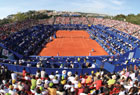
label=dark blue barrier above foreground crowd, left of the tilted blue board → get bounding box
[0,63,100,75]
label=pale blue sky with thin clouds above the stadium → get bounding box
[0,0,140,19]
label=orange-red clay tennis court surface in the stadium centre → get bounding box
[39,30,108,56]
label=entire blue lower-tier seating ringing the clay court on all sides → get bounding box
[2,24,140,73]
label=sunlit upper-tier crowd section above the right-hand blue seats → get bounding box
[88,17,140,38]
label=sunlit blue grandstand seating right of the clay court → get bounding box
[90,25,140,55]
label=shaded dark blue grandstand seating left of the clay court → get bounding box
[2,25,55,56]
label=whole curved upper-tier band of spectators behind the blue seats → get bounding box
[0,16,140,40]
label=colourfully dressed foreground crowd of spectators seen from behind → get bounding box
[0,63,140,95]
